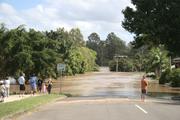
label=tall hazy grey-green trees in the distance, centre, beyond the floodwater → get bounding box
[86,32,129,66]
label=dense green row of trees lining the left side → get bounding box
[0,24,96,78]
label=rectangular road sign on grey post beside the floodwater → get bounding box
[57,63,66,94]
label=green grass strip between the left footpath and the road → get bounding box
[0,94,63,119]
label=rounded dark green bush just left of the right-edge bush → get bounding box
[159,69,171,84]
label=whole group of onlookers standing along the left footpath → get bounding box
[0,73,52,102]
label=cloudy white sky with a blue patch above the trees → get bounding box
[0,0,133,43]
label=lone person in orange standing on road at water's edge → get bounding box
[141,75,148,102]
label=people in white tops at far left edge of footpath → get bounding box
[0,78,10,102]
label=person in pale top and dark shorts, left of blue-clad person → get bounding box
[18,73,26,97]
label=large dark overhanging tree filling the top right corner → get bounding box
[122,0,180,55]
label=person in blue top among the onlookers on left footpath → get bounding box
[29,74,37,96]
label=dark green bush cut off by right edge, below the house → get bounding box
[171,68,180,87]
